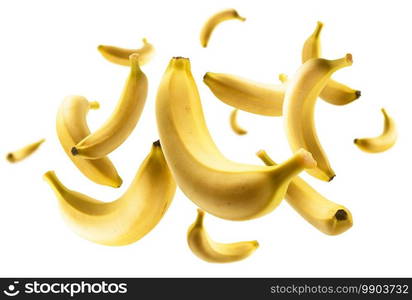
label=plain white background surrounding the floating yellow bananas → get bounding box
[0,0,412,277]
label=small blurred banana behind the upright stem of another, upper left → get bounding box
[97,38,154,66]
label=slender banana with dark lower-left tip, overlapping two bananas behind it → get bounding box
[71,53,148,159]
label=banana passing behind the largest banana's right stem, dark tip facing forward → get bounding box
[256,150,353,235]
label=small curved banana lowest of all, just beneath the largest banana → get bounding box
[187,209,259,263]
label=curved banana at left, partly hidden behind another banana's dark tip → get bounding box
[56,96,122,187]
